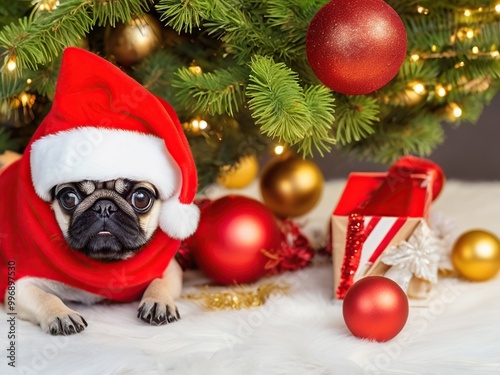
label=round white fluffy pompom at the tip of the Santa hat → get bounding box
[160,197,200,240]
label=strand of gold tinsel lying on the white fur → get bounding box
[182,282,290,311]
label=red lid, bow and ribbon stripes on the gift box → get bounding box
[336,156,445,299]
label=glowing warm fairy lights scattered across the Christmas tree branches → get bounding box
[2,0,500,151]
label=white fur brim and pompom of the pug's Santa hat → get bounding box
[30,126,199,239]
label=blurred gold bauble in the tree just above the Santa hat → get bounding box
[104,14,163,67]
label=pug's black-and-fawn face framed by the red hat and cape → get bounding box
[52,179,161,261]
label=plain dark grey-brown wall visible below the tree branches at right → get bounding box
[314,95,500,181]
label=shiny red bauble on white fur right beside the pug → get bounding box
[190,195,281,284]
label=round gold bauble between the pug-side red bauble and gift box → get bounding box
[260,155,324,217]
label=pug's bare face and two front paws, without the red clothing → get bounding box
[16,179,182,335]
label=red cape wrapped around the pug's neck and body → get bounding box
[0,156,180,302]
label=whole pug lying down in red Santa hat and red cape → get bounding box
[0,47,200,335]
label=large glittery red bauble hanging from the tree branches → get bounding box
[306,0,408,95]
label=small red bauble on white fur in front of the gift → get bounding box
[342,276,409,341]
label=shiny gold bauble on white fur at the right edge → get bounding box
[451,230,500,281]
